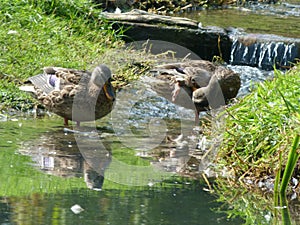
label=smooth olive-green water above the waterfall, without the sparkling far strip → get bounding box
[183,9,300,38]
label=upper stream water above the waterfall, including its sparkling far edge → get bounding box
[182,1,300,38]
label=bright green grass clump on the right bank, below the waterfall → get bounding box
[217,65,300,189]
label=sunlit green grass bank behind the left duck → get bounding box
[0,0,120,109]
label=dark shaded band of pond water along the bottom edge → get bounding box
[0,183,241,225]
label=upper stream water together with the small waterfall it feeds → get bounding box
[182,2,300,70]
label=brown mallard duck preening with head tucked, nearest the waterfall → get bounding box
[150,60,241,123]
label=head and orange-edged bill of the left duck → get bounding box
[91,64,115,101]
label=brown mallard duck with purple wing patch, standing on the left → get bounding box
[20,64,115,126]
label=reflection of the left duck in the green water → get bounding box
[19,131,111,191]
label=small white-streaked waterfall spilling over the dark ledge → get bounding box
[230,35,300,70]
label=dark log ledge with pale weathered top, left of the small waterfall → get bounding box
[102,10,231,62]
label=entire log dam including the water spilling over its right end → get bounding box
[102,10,300,70]
